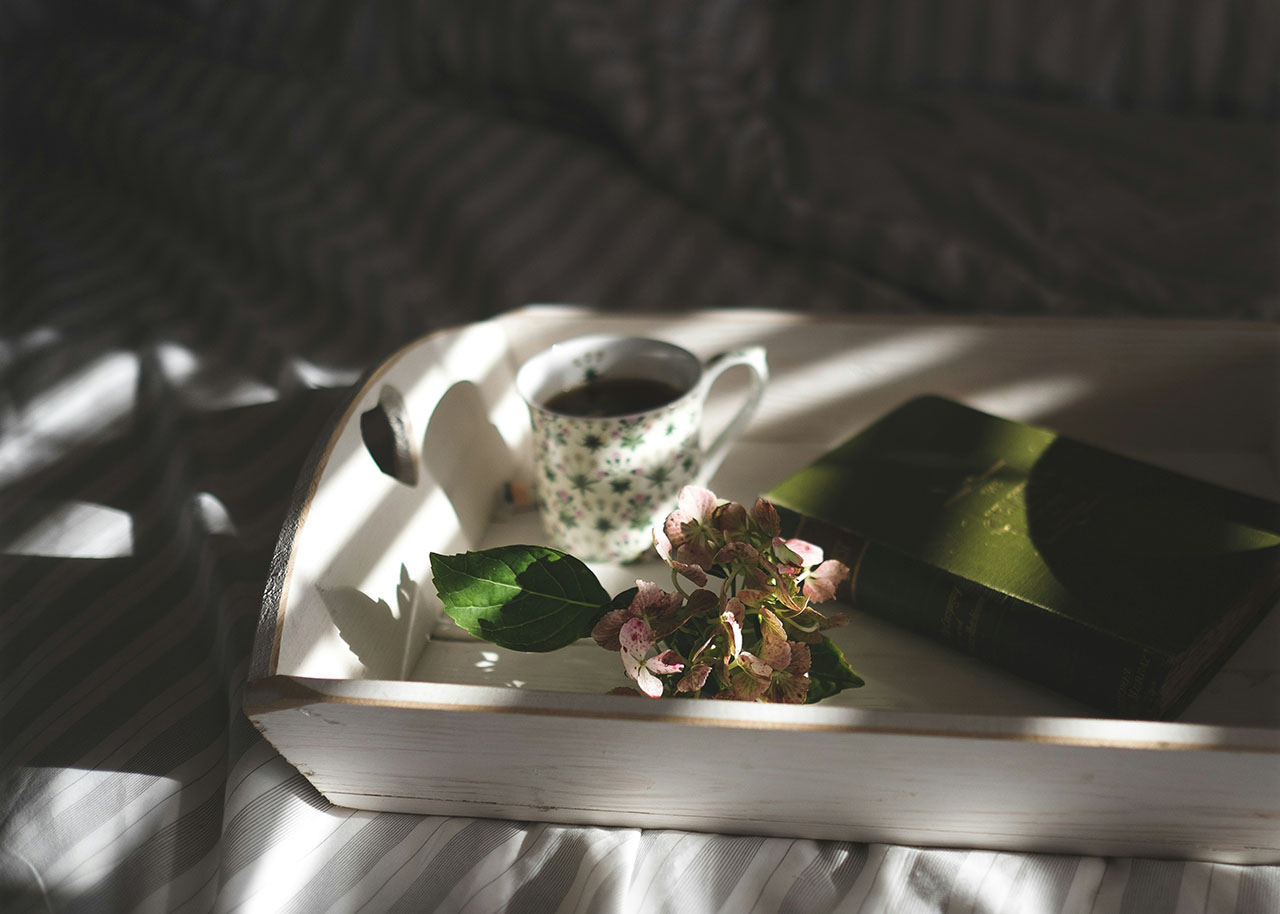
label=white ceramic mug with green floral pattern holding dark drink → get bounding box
[516,335,769,562]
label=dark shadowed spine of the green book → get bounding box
[780,508,1172,718]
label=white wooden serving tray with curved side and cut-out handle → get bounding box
[244,307,1280,863]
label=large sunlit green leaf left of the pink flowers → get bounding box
[431,545,609,650]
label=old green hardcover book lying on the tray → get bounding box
[764,396,1280,719]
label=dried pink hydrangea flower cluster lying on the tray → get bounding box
[591,485,849,704]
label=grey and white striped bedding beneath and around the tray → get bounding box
[0,0,1280,914]
